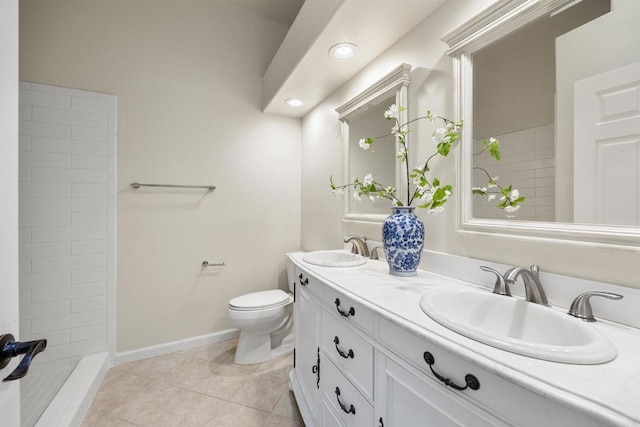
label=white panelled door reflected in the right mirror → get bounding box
[574,62,640,226]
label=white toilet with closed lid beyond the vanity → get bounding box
[228,289,293,365]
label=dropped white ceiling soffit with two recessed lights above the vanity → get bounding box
[260,0,445,117]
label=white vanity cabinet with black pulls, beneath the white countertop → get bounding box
[290,262,632,427]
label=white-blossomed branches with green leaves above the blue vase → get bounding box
[329,104,525,214]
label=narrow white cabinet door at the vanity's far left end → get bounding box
[293,284,321,425]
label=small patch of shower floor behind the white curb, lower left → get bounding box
[20,366,74,427]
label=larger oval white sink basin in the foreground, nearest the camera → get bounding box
[420,288,616,365]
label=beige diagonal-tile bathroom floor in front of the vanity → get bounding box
[82,340,304,427]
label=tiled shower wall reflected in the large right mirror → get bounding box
[473,124,556,222]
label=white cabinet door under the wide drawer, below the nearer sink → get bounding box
[375,353,505,427]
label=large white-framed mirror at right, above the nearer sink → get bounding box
[443,0,640,245]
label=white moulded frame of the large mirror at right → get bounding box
[442,0,640,246]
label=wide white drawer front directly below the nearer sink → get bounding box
[379,319,600,427]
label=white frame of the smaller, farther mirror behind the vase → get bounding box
[336,63,411,222]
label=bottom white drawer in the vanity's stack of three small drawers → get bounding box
[322,359,373,427]
